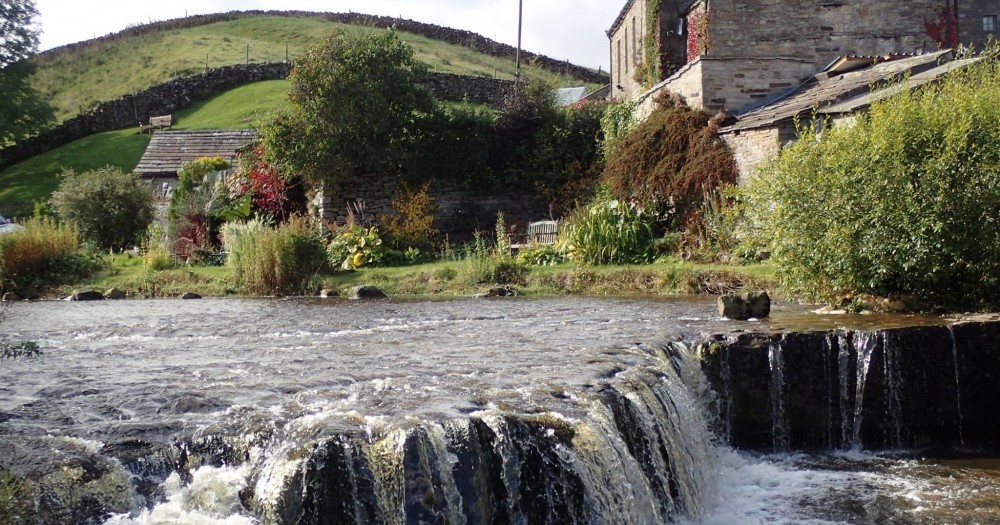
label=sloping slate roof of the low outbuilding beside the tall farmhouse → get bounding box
[720,50,978,133]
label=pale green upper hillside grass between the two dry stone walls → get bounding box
[35,15,596,121]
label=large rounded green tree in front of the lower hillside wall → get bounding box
[261,30,433,183]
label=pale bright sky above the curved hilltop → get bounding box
[35,0,625,71]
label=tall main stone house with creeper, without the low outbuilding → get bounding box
[607,0,1000,113]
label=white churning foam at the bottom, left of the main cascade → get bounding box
[104,467,257,525]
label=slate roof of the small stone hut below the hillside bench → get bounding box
[135,129,257,177]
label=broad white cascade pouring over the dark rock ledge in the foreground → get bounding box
[107,342,717,525]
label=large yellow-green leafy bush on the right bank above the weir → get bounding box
[746,61,1000,308]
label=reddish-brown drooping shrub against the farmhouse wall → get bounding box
[604,96,739,226]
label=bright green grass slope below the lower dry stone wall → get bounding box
[0,80,288,217]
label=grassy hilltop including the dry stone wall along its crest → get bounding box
[34,11,607,121]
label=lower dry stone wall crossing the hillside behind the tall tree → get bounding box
[0,63,513,169]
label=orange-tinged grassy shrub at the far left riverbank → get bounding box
[0,217,100,297]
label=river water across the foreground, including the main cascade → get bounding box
[0,298,1000,524]
